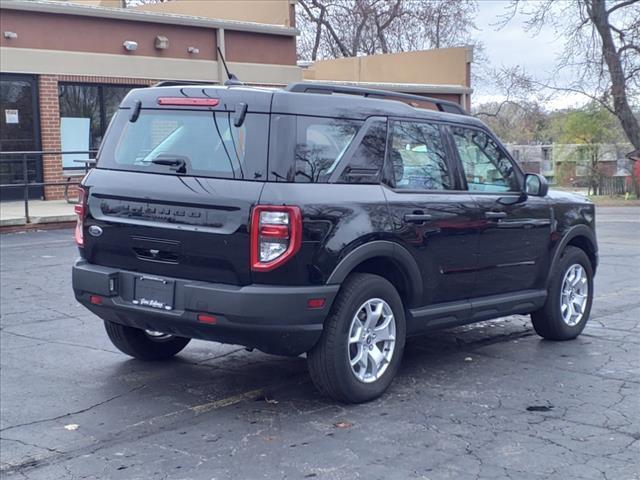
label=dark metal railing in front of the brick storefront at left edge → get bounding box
[0,150,97,223]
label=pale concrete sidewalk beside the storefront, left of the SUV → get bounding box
[0,200,76,227]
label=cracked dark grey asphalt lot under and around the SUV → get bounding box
[0,207,640,480]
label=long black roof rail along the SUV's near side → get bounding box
[285,82,468,115]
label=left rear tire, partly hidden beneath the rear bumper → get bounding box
[104,320,191,361]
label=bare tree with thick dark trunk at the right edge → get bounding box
[503,0,640,149]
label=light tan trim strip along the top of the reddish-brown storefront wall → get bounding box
[0,0,300,37]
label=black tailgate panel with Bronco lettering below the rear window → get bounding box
[84,169,263,285]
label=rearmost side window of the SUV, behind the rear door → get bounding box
[295,116,362,183]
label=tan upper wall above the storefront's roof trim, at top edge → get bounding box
[135,0,295,27]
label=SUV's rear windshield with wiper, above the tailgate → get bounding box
[98,109,269,180]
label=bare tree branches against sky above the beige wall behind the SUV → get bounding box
[296,0,477,60]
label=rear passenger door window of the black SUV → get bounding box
[389,121,453,190]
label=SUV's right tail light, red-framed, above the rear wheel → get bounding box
[251,205,302,272]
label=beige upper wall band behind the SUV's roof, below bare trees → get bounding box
[303,47,472,87]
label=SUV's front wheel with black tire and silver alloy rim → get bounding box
[531,246,593,340]
